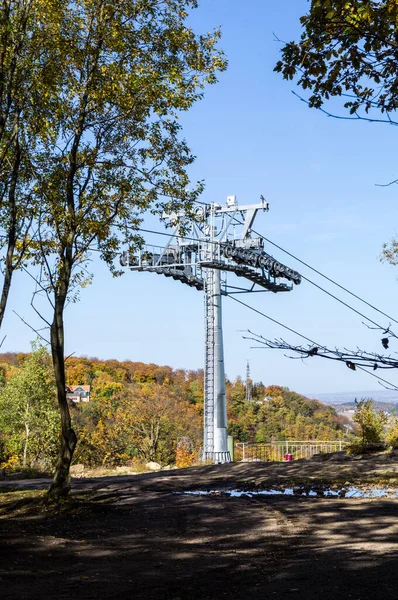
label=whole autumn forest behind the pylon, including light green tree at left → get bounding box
[0,346,344,472]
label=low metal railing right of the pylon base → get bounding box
[235,440,348,462]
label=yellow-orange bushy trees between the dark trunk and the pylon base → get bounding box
[72,383,201,466]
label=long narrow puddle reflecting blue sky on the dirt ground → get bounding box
[173,486,398,498]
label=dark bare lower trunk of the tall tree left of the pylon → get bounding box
[48,272,77,498]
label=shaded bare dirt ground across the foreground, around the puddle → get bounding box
[0,453,398,600]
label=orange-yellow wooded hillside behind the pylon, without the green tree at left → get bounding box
[0,354,352,470]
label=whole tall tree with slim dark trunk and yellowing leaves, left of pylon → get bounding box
[31,0,225,496]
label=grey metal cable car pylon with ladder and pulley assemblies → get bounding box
[120,196,301,463]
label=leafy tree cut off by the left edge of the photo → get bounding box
[0,0,62,327]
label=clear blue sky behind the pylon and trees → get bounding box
[2,0,398,393]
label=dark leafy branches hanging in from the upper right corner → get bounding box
[275,0,398,264]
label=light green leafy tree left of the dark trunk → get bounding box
[0,347,59,470]
